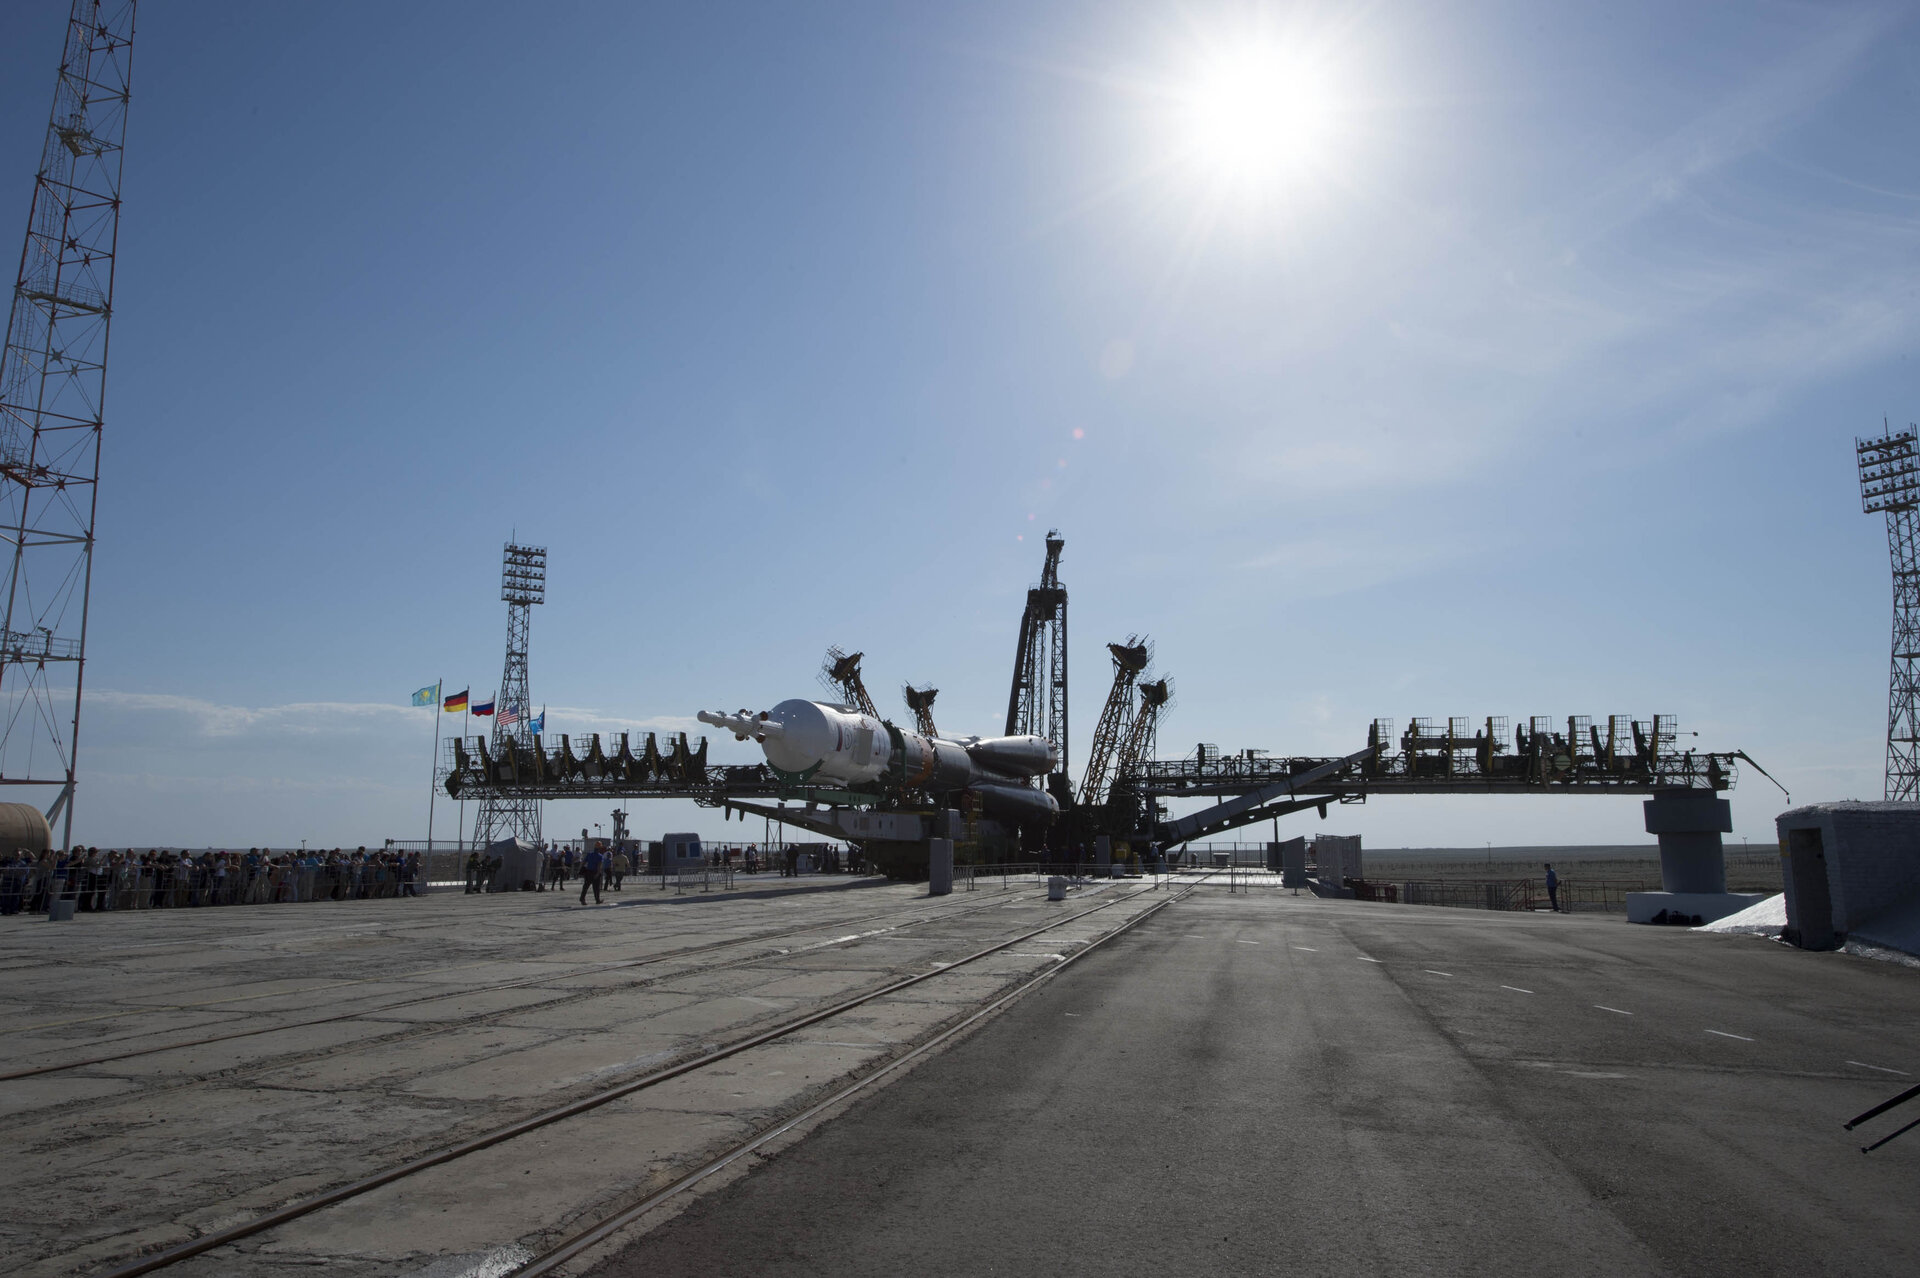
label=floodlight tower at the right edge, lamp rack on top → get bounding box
[1853,426,1920,800]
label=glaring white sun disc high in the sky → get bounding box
[1179,44,1334,190]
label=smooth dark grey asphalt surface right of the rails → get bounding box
[595,890,1920,1278]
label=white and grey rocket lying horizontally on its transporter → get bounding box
[699,698,1060,821]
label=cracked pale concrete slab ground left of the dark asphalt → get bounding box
[0,877,1164,1276]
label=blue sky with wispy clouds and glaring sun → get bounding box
[0,0,1920,846]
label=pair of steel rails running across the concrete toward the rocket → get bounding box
[102,885,1194,1278]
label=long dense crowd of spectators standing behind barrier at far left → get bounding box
[0,846,422,913]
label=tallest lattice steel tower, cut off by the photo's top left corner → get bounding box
[0,0,134,846]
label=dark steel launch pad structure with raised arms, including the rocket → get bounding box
[442,532,1759,892]
